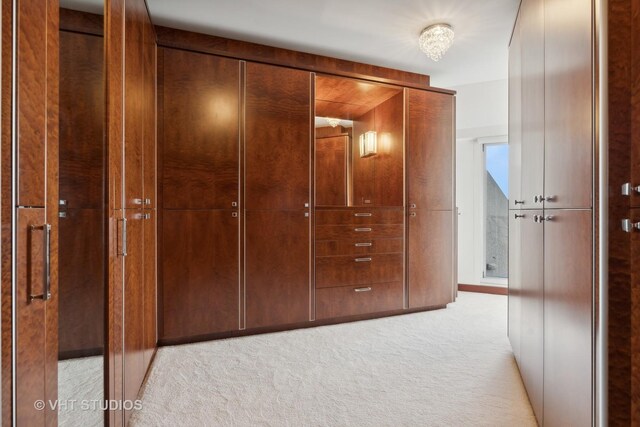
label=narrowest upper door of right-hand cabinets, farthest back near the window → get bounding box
[509,13,523,209]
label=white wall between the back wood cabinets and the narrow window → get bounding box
[453,79,509,285]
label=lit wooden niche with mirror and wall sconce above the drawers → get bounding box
[315,76,404,207]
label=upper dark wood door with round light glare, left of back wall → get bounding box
[162,49,240,209]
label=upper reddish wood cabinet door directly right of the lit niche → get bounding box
[406,89,455,210]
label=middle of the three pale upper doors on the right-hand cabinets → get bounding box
[514,0,545,209]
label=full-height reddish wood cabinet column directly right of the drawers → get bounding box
[405,89,455,308]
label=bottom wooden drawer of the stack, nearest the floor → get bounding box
[316,282,403,320]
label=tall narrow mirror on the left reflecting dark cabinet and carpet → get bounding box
[58,0,107,426]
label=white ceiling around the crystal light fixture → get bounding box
[147,0,520,87]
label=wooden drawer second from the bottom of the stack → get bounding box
[316,254,403,288]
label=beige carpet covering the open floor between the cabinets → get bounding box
[131,293,536,426]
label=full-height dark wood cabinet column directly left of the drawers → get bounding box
[244,63,313,328]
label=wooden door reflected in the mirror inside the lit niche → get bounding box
[315,136,350,206]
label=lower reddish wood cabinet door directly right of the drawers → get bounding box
[407,209,455,308]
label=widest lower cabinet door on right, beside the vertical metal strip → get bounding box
[544,210,594,426]
